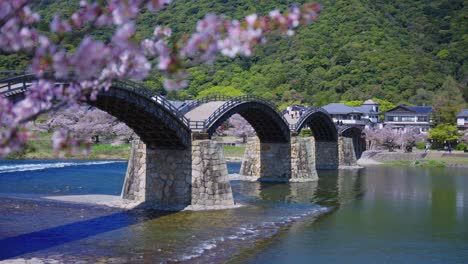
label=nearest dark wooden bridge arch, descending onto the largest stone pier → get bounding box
[0,74,191,149]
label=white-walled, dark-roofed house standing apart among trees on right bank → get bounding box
[384,105,432,133]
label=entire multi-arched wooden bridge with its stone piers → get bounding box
[0,71,365,209]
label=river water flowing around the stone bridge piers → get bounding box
[0,160,468,263]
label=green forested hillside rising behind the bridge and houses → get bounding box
[0,0,468,107]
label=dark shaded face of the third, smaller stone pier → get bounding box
[315,141,339,170]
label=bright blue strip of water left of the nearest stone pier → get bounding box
[0,160,127,195]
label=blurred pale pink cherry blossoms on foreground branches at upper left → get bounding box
[0,0,320,156]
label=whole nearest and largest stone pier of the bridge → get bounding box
[121,140,234,210]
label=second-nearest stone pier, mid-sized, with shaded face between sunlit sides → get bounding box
[240,136,318,182]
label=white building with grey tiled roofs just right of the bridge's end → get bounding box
[322,100,380,128]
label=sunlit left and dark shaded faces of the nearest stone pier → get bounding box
[122,141,192,210]
